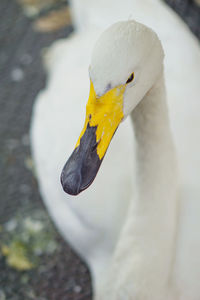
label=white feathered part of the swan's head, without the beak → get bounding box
[89,20,164,117]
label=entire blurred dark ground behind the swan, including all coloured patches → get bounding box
[0,0,200,300]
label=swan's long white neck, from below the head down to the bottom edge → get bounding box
[98,71,177,300]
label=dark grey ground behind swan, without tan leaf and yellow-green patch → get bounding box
[0,0,200,300]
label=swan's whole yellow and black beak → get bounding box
[61,81,125,195]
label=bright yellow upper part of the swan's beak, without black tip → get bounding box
[76,81,125,160]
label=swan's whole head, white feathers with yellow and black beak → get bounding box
[61,21,164,195]
